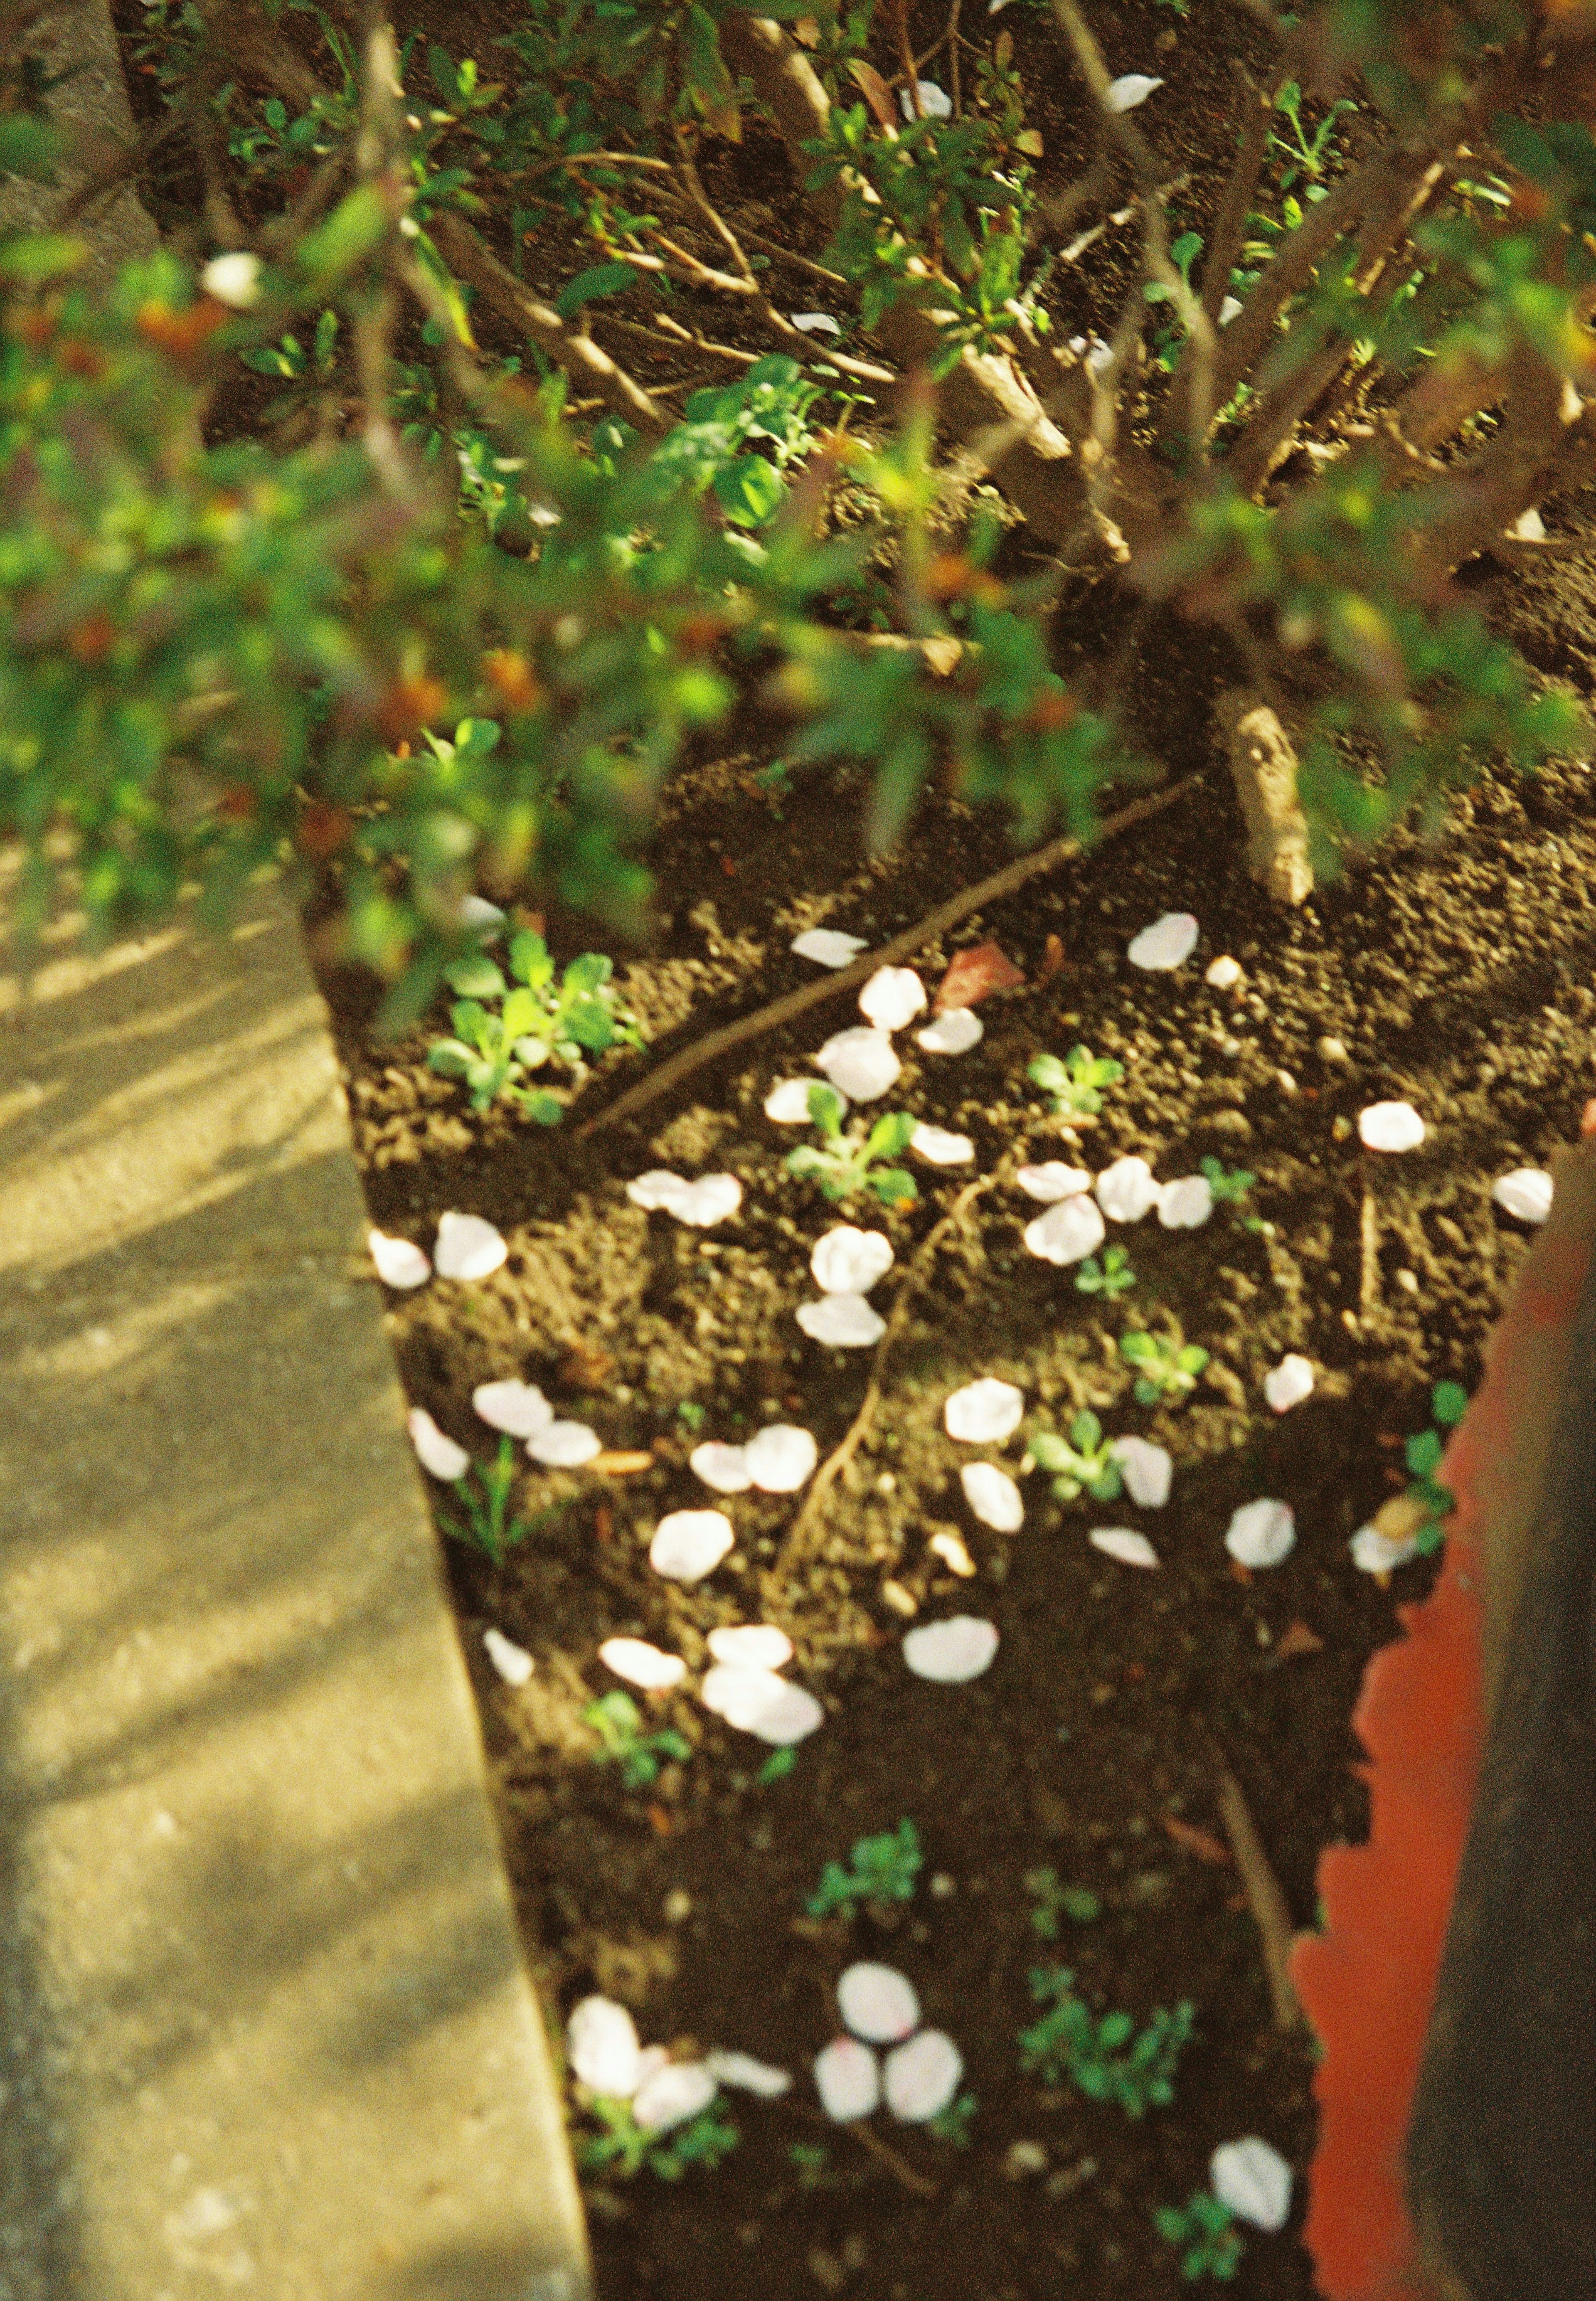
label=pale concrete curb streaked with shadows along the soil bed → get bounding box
[0,881,591,2301]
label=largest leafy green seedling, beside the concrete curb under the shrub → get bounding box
[428,932,644,1125]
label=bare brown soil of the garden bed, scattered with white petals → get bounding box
[106,0,1596,2301]
